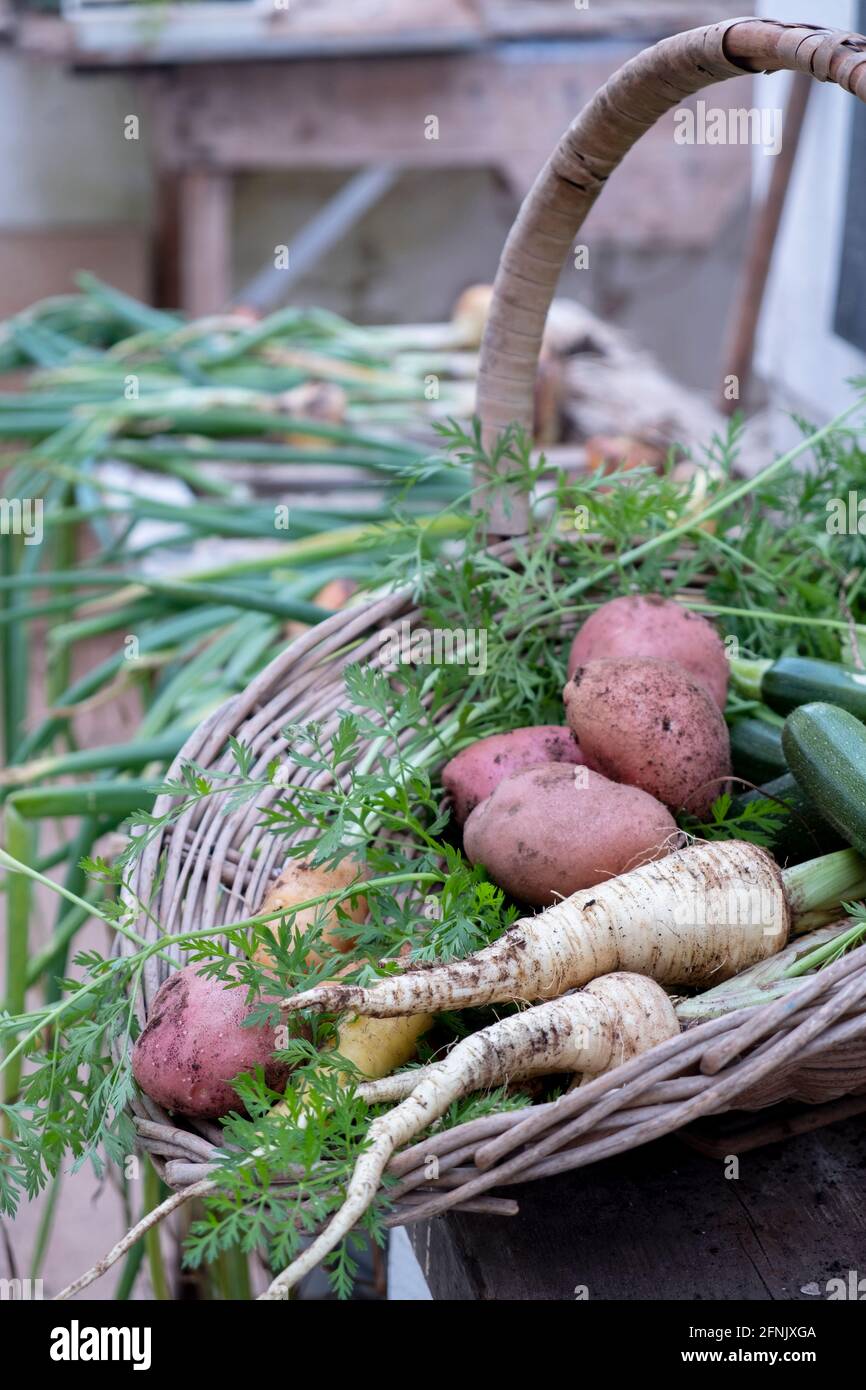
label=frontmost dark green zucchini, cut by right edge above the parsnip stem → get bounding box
[781,703,866,853]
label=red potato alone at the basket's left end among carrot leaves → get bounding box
[132,965,289,1119]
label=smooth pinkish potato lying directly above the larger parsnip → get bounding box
[463,763,677,908]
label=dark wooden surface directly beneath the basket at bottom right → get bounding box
[409,1116,866,1301]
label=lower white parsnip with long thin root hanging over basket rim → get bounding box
[261,974,680,1298]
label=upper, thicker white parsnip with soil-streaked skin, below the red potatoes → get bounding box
[282,840,802,1017]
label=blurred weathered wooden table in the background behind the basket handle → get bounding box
[16,0,751,314]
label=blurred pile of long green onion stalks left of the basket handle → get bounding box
[0,277,475,1067]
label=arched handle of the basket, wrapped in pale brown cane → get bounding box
[475,18,866,535]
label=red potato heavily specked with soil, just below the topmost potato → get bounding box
[563,659,731,816]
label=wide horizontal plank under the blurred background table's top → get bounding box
[142,43,753,247]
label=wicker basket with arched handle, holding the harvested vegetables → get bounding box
[121,19,866,1222]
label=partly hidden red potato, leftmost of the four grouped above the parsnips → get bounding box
[442,724,585,826]
